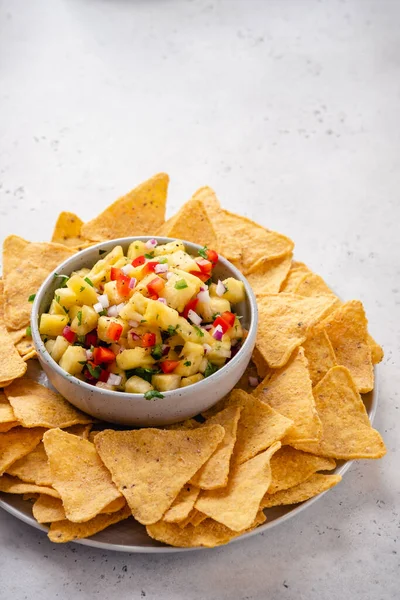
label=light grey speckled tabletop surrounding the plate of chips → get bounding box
[0,0,400,600]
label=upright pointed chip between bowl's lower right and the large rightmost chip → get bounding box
[254,348,322,444]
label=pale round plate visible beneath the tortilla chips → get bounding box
[0,361,378,553]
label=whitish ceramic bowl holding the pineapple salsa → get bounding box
[31,237,258,426]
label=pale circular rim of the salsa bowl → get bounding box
[30,235,258,403]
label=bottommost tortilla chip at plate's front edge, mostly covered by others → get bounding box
[146,511,266,548]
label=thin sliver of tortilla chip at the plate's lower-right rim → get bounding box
[261,473,342,508]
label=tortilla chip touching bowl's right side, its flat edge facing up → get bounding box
[256,294,335,369]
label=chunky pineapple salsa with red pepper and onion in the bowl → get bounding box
[39,239,246,399]
